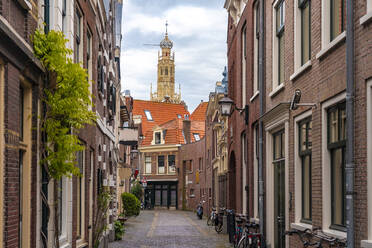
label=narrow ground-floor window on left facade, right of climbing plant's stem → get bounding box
[76,151,85,239]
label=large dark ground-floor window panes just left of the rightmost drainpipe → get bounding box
[327,103,346,230]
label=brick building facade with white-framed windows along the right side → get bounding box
[225,0,372,247]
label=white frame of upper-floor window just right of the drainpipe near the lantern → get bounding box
[269,0,286,97]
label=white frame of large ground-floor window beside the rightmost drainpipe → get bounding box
[322,92,346,238]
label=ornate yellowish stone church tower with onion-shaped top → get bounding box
[150,23,181,103]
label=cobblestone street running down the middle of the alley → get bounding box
[109,210,232,248]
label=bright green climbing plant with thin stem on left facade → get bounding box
[32,29,96,248]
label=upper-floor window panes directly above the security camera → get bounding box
[298,0,311,66]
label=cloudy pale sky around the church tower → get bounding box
[121,0,227,111]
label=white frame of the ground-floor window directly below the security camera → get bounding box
[291,110,312,230]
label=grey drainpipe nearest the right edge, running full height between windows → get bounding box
[345,0,354,248]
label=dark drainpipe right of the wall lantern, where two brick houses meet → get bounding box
[258,0,266,244]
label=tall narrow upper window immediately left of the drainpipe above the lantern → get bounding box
[253,1,260,94]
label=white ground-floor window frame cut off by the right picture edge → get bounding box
[361,79,372,248]
